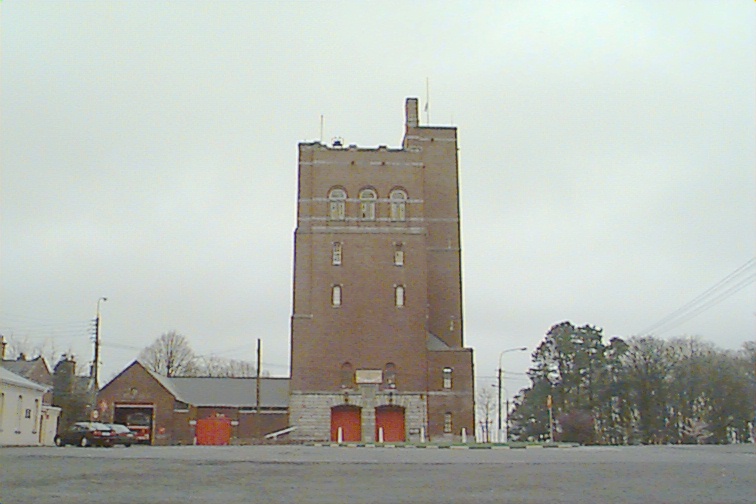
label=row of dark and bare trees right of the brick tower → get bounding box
[509,322,756,444]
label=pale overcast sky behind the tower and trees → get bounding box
[0,0,756,390]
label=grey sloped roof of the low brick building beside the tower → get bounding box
[170,377,289,408]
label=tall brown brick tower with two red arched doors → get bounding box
[290,98,474,442]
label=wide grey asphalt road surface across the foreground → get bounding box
[0,445,756,504]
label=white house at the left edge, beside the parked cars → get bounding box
[0,367,60,446]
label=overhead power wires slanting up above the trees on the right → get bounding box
[640,257,756,334]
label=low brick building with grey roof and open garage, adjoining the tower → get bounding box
[97,361,289,445]
